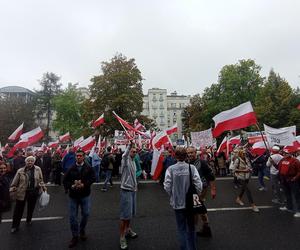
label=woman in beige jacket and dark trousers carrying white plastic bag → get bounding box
[10,156,46,233]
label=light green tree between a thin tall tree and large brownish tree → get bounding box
[53,83,88,138]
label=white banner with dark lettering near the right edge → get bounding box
[264,124,296,147]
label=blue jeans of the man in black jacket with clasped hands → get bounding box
[69,196,91,237]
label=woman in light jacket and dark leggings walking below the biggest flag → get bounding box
[232,149,259,212]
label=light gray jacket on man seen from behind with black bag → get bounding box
[164,161,202,209]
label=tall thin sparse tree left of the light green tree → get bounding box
[37,72,61,140]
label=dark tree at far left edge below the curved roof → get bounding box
[0,96,36,145]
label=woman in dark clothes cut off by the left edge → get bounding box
[0,162,10,223]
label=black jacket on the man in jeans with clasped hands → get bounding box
[63,162,96,199]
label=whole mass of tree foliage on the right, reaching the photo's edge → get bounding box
[183,60,300,136]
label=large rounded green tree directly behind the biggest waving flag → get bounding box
[184,59,264,131]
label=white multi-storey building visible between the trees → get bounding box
[142,88,191,138]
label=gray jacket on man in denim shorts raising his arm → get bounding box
[121,145,137,192]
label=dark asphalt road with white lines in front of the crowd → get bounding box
[0,179,300,250]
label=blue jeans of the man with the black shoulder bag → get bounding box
[174,209,197,250]
